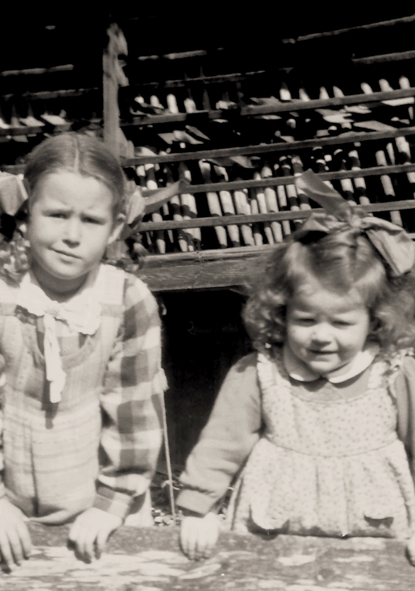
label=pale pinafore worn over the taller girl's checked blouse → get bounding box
[0,266,126,523]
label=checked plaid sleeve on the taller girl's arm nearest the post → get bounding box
[94,277,166,519]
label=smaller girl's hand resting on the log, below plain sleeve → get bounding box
[180,513,220,560]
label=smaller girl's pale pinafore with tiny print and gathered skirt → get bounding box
[228,350,415,538]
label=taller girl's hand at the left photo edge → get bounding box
[0,498,32,570]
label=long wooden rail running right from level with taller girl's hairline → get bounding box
[122,127,415,168]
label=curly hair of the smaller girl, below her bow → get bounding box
[243,227,415,351]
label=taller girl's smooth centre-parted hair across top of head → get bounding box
[25,133,125,217]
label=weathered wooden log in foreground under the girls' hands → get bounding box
[0,524,415,591]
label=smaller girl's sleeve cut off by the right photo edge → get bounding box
[395,356,415,480]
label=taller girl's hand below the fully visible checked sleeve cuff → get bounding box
[69,507,122,562]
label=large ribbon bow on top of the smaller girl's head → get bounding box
[295,170,415,277]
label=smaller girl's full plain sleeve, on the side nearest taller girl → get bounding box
[177,354,262,515]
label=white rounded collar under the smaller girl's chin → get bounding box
[283,342,379,384]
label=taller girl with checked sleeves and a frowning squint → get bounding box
[0,134,164,567]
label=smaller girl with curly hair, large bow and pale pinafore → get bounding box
[178,172,415,558]
